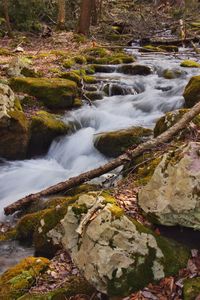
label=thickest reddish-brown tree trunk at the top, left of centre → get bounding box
[77,0,94,35]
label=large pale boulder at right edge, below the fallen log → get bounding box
[138,142,200,230]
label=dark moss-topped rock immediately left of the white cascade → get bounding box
[28,111,71,156]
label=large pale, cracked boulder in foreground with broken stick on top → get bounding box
[56,192,189,296]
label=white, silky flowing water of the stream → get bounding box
[0,48,198,220]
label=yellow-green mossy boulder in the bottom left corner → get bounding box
[0,257,49,300]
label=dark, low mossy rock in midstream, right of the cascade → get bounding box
[94,127,152,157]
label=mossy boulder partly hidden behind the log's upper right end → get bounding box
[154,109,200,138]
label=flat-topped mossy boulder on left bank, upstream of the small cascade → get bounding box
[10,77,78,109]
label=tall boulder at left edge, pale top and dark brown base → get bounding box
[0,84,28,159]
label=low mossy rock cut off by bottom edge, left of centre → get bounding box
[20,276,95,300]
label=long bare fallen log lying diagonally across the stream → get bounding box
[4,102,200,215]
